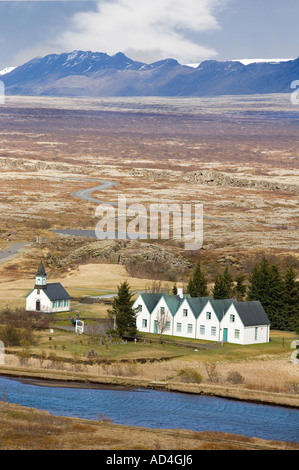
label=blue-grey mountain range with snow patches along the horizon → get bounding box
[1,51,299,97]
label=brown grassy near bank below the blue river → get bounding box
[0,401,299,454]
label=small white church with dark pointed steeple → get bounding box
[26,261,71,313]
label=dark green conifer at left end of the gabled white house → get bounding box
[108,281,137,337]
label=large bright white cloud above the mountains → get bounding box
[55,0,230,63]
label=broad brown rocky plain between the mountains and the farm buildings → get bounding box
[0,95,299,280]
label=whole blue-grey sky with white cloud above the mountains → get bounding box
[0,0,299,70]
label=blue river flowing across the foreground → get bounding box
[0,377,299,442]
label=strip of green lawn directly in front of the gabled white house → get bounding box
[20,326,294,362]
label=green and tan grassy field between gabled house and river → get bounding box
[0,325,299,406]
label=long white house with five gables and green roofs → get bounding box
[133,289,270,344]
